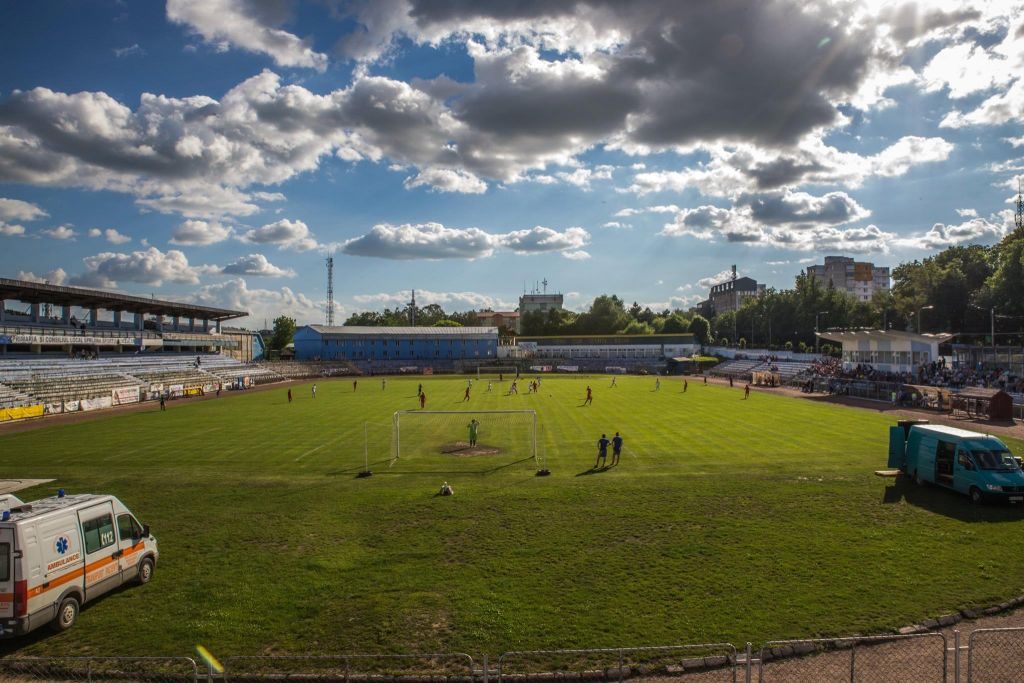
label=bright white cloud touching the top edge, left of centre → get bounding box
[167,0,328,72]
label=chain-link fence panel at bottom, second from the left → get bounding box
[220,652,478,683]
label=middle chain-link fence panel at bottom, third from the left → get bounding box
[497,643,737,683]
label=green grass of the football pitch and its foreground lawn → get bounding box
[0,377,1024,655]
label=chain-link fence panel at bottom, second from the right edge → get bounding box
[758,633,955,683]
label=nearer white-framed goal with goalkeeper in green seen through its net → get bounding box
[391,411,540,469]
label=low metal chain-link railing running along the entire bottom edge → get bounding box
[6,627,1024,683]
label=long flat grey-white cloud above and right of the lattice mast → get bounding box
[342,223,590,260]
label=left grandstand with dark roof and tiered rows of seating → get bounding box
[0,278,287,421]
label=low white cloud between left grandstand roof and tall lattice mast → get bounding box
[191,278,321,325]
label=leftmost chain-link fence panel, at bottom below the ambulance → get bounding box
[0,656,199,683]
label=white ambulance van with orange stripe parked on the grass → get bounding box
[0,489,160,638]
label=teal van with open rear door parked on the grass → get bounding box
[889,422,1024,503]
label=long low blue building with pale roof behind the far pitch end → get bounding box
[293,325,498,367]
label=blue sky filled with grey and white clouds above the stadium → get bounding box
[0,0,1024,328]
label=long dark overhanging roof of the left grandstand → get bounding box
[0,278,249,321]
